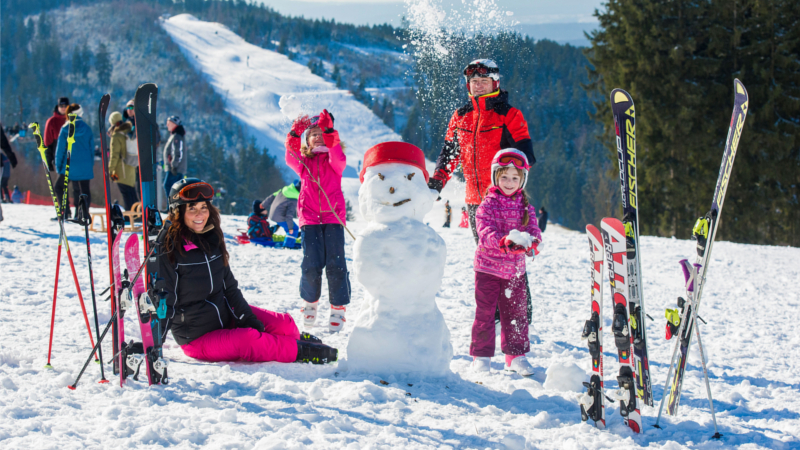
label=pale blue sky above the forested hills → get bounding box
[255,0,602,45]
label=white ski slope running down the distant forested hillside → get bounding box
[161,14,401,177]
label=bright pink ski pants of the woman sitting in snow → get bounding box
[181,305,300,362]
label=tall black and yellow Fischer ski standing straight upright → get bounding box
[611,89,653,406]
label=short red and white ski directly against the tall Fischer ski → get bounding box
[600,218,642,433]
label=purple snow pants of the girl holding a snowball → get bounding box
[469,272,531,357]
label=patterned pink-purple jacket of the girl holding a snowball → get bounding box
[475,186,542,280]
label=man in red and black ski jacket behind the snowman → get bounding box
[428,59,536,243]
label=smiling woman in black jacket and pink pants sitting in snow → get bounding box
[159,178,337,364]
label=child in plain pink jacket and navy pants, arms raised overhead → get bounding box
[286,110,350,331]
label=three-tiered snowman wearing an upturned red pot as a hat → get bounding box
[347,142,453,376]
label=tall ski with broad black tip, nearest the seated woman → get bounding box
[133,83,169,385]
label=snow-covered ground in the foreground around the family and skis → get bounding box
[0,205,800,449]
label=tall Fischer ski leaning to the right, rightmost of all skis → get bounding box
[659,79,749,418]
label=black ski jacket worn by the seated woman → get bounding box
[158,232,255,345]
